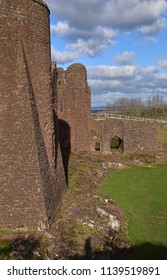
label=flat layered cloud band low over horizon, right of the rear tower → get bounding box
[88,65,167,106]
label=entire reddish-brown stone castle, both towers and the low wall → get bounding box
[0,0,167,229]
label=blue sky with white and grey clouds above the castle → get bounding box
[45,0,167,106]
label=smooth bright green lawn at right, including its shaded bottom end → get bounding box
[100,164,167,259]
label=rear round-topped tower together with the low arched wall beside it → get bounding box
[54,61,167,154]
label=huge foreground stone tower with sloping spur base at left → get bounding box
[0,0,66,228]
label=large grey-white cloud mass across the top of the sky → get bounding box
[45,0,167,63]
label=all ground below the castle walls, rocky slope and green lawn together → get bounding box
[0,152,167,260]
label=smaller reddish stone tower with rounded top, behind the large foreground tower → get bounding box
[55,64,91,151]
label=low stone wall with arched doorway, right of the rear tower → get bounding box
[90,119,167,152]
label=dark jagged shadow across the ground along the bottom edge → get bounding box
[0,236,167,260]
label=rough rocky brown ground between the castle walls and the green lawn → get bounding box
[0,151,167,259]
